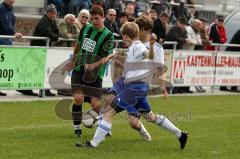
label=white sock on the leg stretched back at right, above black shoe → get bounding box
[155,115,182,138]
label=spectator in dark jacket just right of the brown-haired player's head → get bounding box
[152,12,169,44]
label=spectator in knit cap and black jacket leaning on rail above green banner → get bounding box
[30,4,59,96]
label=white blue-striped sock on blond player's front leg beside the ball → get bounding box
[91,119,112,147]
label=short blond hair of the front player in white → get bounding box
[120,22,139,39]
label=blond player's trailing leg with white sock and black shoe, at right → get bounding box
[145,112,188,149]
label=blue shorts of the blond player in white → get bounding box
[111,77,151,116]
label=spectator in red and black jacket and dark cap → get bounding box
[206,15,227,50]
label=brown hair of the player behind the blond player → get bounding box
[135,16,153,30]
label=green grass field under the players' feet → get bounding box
[0,95,240,159]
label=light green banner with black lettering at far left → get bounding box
[0,47,47,90]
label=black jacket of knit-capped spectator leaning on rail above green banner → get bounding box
[30,15,59,46]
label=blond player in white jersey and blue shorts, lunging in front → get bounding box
[85,22,187,148]
